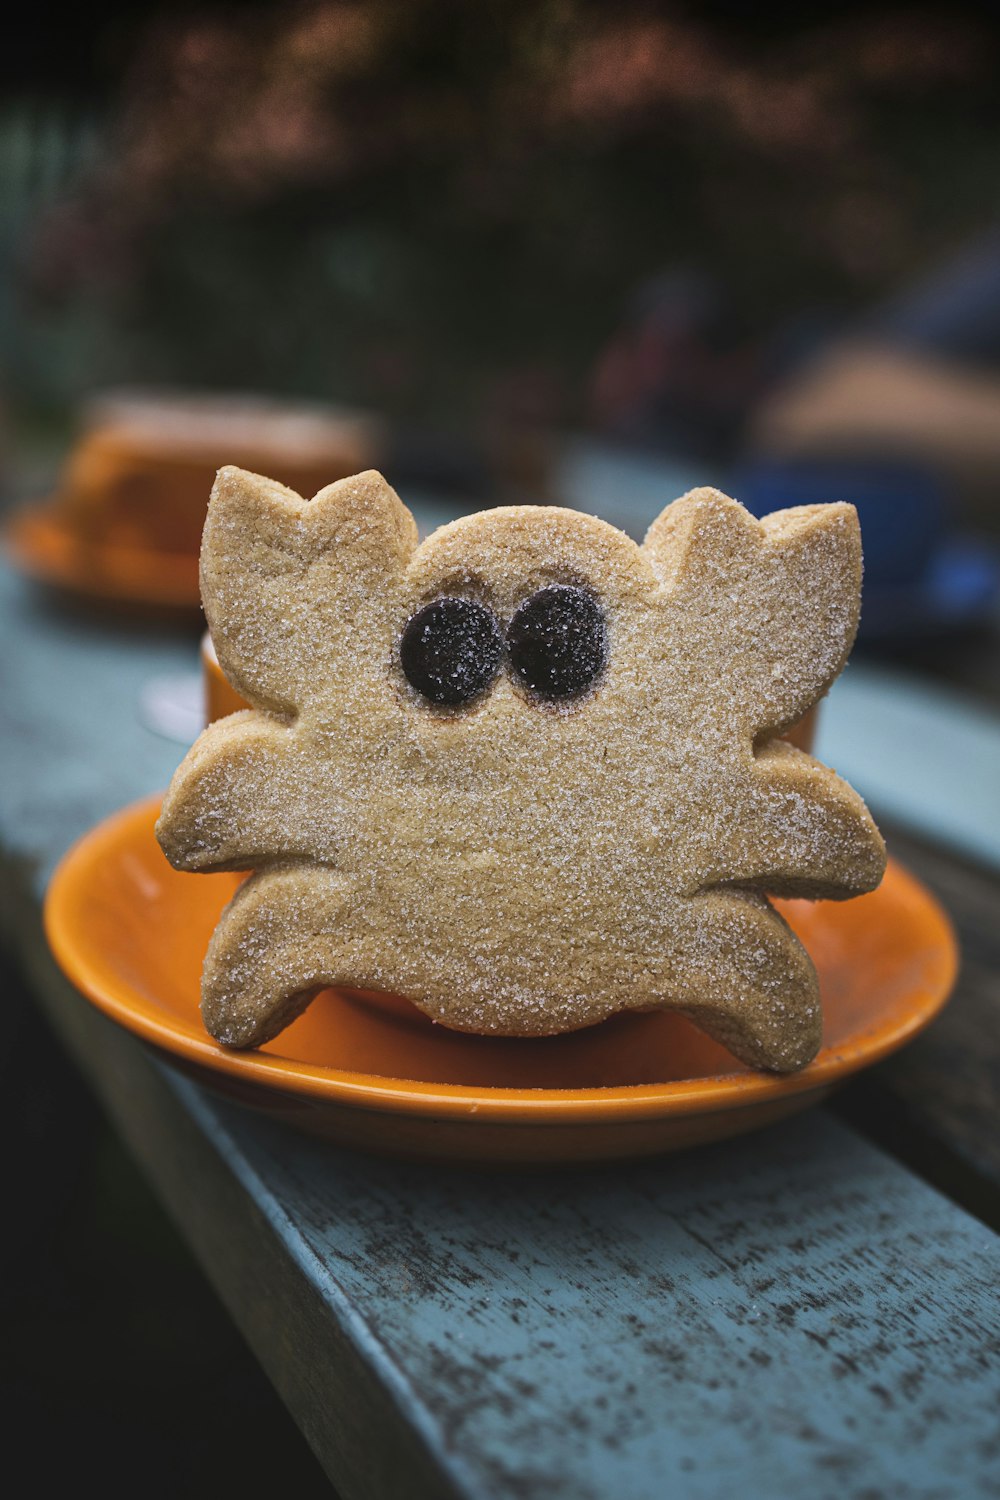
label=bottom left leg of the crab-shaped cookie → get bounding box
[201,866,355,1047]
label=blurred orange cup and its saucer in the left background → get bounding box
[4,389,385,612]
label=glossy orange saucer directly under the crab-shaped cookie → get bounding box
[45,801,958,1163]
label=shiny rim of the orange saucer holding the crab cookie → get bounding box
[43,794,960,1127]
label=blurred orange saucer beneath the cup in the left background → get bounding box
[3,504,201,614]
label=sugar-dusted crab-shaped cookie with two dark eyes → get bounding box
[157,468,885,1070]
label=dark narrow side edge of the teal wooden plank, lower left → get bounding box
[10,945,457,1500]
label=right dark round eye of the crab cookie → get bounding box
[507,584,607,698]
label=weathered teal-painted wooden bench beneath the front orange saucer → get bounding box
[0,555,1000,1500]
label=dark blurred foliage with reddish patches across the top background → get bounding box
[0,0,1000,426]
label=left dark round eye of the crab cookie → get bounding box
[399,599,504,704]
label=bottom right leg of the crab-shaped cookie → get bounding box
[666,891,823,1073]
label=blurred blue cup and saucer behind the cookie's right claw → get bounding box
[732,459,1000,642]
